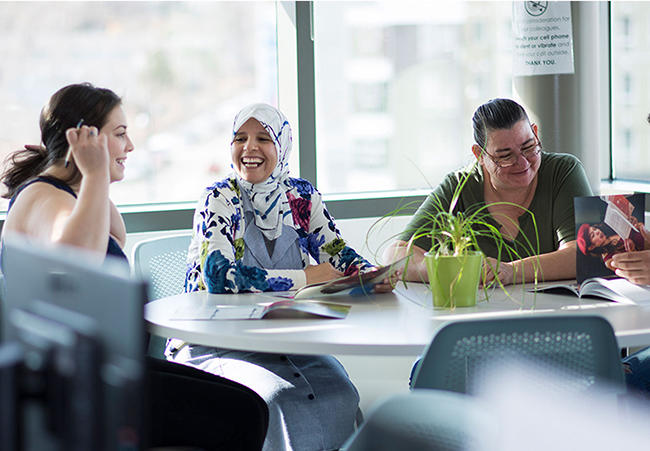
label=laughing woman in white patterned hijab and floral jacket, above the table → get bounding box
[185,104,371,293]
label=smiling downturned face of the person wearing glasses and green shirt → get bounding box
[472,119,542,189]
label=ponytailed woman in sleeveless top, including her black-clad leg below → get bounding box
[2,83,268,450]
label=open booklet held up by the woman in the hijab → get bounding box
[289,257,408,300]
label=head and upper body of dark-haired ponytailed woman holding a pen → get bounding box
[2,83,125,256]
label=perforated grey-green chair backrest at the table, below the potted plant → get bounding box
[412,315,625,393]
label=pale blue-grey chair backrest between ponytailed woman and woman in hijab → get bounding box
[132,233,192,301]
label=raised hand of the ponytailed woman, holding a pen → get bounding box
[65,125,109,177]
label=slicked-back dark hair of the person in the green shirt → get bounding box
[472,99,530,149]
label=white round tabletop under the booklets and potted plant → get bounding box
[145,283,650,356]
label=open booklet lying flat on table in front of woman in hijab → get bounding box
[172,300,350,321]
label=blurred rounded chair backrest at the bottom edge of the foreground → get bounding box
[341,390,492,451]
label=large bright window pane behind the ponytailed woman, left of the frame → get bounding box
[0,2,277,210]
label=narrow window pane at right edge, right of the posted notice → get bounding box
[611,2,650,181]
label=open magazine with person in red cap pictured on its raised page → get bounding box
[533,193,650,305]
